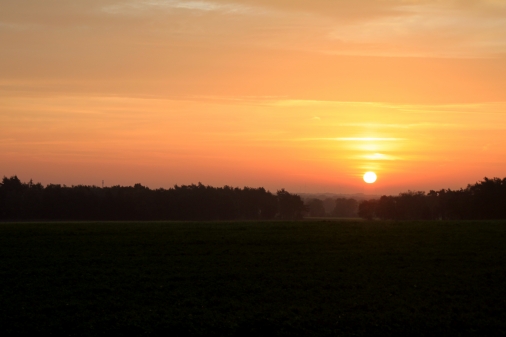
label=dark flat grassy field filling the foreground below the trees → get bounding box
[0,221,506,336]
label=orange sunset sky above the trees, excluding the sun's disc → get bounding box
[0,0,506,194]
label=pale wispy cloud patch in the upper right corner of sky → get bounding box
[329,1,506,57]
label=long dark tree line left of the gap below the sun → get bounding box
[0,176,305,221]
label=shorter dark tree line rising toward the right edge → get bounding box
[358,177,506,220]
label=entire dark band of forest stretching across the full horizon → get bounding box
[0,176,506,221]
